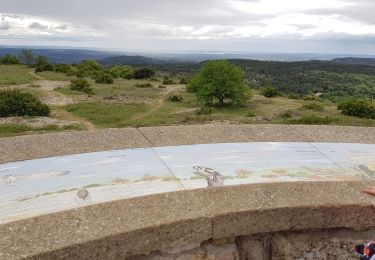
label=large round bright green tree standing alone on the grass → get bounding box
[187,61,250,106]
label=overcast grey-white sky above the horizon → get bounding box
[0,0,375,54]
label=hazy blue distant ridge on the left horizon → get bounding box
[0,47,119,64]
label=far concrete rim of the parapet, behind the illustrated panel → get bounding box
[0,124,375,163]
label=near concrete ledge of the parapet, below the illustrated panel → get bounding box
[0,182,375,259]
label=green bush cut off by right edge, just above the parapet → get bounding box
[337,99,375,119]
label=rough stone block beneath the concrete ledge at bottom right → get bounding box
[272,229,375,260]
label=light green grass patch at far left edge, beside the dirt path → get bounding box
[0,65,37,86]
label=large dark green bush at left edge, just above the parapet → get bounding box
[0,90,51,117]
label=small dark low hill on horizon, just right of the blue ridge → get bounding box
[98,55,172,66]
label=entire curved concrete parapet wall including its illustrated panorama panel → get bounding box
[0,125,375,259]
